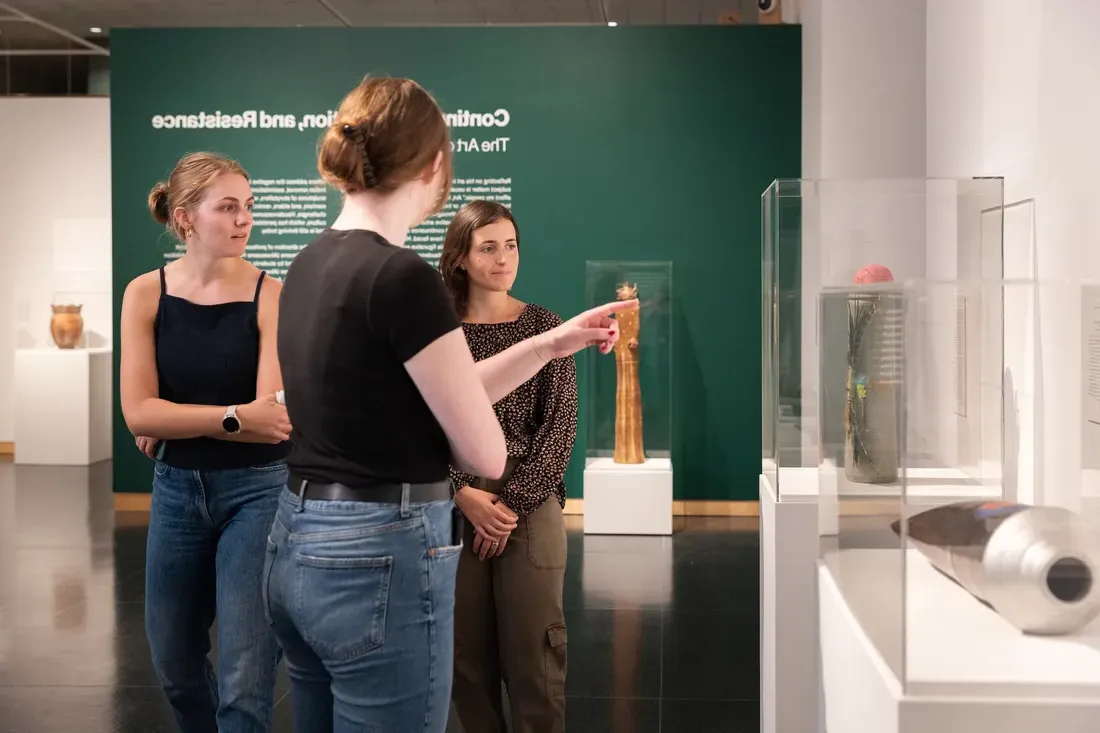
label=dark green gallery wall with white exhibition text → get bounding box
[111,25,802,501]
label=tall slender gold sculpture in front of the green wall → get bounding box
[613,283,646,463]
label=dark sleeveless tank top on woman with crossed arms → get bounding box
[153,267,289,470]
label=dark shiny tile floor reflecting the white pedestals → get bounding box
[0,462,759,733]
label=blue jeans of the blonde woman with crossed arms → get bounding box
[145,461,287,733]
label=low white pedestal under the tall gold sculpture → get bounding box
[584,458,672,535]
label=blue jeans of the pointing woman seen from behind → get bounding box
[264,489,462,733]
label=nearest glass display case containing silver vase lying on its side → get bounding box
[817,278,1100,704]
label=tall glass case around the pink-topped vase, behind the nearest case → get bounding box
[760,173,1004,501]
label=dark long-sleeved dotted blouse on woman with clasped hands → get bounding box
[451,304,578,516]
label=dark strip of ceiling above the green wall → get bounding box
[0,0,774,48]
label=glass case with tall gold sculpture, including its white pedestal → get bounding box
[583,261,673,534]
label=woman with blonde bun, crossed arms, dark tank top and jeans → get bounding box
[119,153,290,733]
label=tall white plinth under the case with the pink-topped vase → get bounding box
[760,468,824,733]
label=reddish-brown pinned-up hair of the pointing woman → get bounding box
[317,77,451,214]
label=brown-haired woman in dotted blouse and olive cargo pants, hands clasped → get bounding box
[439,200,578,733]
